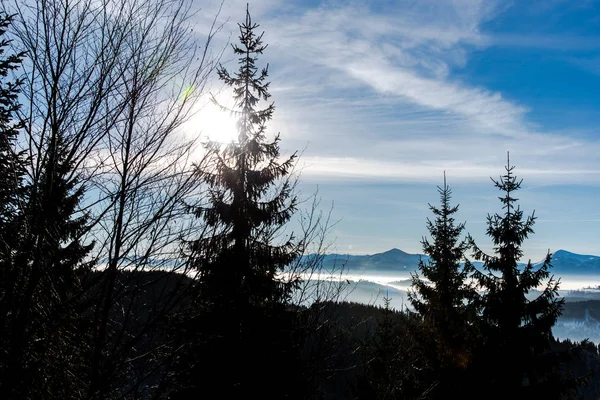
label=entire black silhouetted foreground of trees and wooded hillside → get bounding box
[0,0,600,399]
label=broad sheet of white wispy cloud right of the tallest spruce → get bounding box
[190,0,600,183]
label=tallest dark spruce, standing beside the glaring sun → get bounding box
[194,4,297,314]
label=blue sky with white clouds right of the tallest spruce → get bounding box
[185,0,600,261]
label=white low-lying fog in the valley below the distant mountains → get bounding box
[296,271,600,344]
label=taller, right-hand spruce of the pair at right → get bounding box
[469,152,575,399]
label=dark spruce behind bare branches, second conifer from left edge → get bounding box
[1,125,92,399]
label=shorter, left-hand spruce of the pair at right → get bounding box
[408,173,477,397]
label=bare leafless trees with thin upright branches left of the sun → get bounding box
[2,0,225,398]
